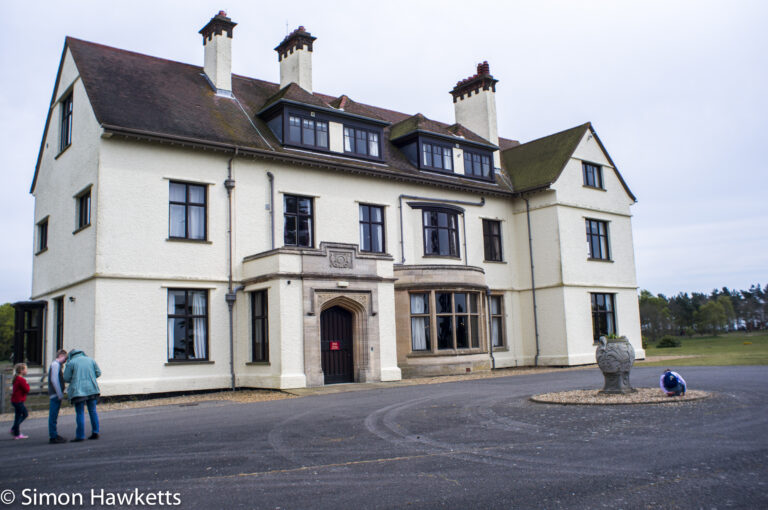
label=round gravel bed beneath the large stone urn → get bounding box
[530,388,712,405]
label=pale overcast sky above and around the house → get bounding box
[0,0,768,303]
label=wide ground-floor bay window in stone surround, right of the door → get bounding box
[409,290,480,352]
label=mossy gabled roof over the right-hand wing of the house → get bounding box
[501,122,637,202]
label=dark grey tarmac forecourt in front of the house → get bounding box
[0,366,768,509]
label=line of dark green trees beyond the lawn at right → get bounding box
[639,284,768,342]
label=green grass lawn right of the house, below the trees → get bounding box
[638,331,768,367]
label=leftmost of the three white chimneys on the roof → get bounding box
[200,11,237,95]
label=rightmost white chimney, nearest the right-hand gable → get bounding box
[451,61,499,148]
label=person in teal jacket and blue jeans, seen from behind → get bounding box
[64,349,101,442]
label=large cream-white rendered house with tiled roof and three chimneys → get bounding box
[15,12,644,395]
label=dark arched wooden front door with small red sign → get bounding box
[320,306,355,384]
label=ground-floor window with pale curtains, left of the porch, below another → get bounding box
[168,289,208,361]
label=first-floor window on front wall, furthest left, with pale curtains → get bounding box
[168,181,208,240]
